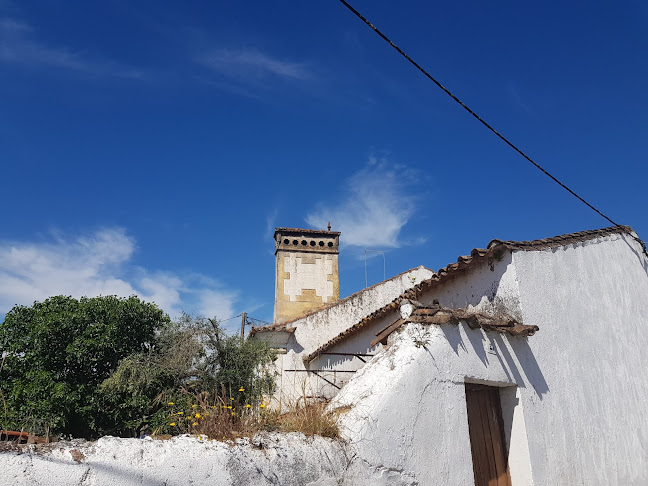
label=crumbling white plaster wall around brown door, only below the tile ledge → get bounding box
[330,324,532,486]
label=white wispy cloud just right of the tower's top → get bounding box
[306,158,416,248]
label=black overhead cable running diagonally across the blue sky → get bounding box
[339,0,648,256]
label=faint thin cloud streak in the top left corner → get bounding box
[0,18,142,78]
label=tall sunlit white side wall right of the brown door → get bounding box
[513,231,648,485]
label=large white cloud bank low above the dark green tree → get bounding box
[0,228,238,319]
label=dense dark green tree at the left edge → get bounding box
[0,296,169,437]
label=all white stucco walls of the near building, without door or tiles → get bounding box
[331,235,648,486]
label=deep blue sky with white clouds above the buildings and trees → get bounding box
[0,0,648,330]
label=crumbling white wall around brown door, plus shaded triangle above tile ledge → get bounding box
[330,252,535,486]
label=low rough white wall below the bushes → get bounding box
[0,434,355,486]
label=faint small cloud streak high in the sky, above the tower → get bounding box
[197,49,309,82]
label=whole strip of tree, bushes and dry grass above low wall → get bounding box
[0,296,338,440]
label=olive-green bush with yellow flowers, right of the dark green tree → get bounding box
[101,315,276,436]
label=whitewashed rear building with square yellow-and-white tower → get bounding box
[251,228,434,408]
